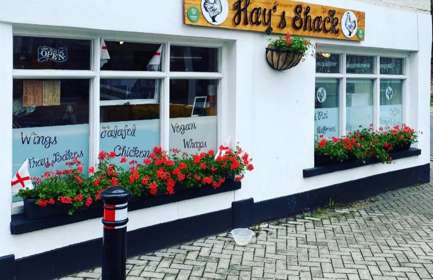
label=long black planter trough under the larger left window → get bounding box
[23,178,241,220]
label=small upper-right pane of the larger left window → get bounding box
[170,46,218,72]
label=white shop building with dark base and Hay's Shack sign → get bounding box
[0,0,432,279]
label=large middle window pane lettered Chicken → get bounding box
[100,80,160,163]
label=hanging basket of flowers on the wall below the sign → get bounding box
[266,33,311,71]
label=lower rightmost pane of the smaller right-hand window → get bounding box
[380,80,403,127]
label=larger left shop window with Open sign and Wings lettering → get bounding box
[12,36,223,211]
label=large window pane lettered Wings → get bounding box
[12,80,89,195]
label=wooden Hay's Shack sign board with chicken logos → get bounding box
[184,0,365,41]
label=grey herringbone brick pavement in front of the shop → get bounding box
[62,173,433,280]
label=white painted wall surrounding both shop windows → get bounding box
[0,0,432,258]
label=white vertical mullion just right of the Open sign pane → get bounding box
[89,37,101,166]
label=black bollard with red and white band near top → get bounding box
[102,187,129,280]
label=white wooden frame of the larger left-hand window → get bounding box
[11,29,228,213]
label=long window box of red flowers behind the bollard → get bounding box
[19,146,254,219]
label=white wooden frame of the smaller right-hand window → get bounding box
[316,46,410,137]
